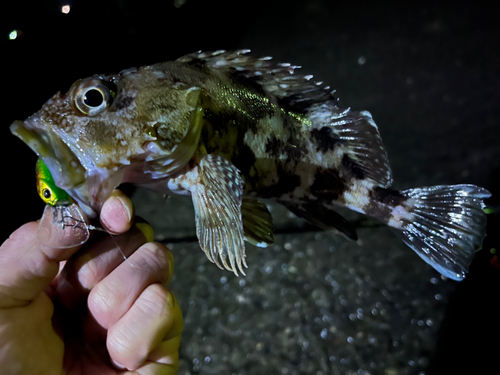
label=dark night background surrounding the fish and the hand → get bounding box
[0,0,500,375]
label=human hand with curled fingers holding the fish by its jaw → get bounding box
[0,190,183,375]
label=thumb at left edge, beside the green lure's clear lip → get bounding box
[0,222,84,309]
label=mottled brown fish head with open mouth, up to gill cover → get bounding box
[10,67,205,217]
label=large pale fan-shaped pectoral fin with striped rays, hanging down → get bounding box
[189,155,248,276]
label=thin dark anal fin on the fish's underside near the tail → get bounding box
[285,203,358,241]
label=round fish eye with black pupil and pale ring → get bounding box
[73,78,115,116]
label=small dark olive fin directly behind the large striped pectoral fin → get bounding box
[241,197,274,247]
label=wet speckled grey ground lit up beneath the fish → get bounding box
[134,192,455,375]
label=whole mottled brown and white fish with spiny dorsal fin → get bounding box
[11,51,490,280]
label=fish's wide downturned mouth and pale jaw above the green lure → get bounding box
[10,118,85,190]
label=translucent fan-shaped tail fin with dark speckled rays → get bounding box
[391,185,491,281]
